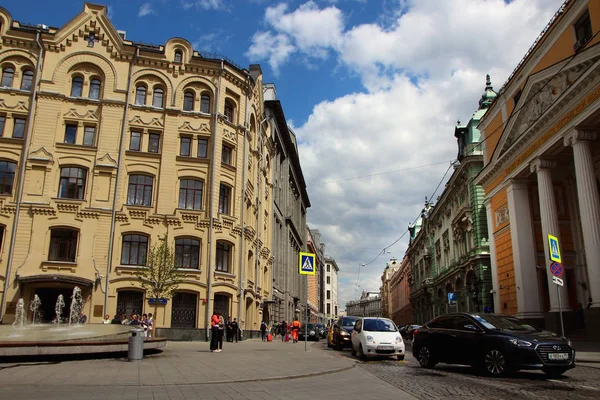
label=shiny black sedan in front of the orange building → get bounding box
[412,313,575,376]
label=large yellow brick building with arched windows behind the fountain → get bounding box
[0,3,274,338]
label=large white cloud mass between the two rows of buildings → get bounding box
[247,0,562,309]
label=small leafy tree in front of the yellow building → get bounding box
[137,235,181,337]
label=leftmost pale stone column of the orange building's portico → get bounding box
[506,179,544,319]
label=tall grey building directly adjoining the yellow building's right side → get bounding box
[263,84,310,322]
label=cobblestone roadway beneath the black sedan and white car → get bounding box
[327,342,600,400]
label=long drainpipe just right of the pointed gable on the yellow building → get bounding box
[104,46,140,314]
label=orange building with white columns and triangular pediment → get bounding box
[478,0,600,337]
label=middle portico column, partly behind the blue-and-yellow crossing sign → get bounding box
[531,158,570,312]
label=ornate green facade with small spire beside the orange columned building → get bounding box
[406,76,496,324]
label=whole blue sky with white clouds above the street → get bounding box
[2,0,563,309]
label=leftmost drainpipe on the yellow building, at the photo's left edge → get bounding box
[0,30,44,322]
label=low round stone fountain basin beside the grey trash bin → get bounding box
[0,324,167,357]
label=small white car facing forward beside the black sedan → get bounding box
[352,317,405,360]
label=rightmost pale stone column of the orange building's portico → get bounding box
[564,130,600,308]
